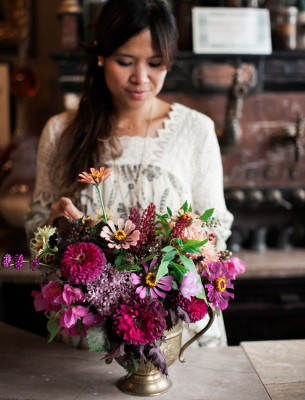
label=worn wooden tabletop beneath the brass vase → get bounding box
[0,322,305,400]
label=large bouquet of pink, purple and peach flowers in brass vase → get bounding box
[2,167,245,374]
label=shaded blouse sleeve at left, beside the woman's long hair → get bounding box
[25,113,67,238]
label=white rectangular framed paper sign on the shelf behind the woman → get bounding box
[192,7,272,54]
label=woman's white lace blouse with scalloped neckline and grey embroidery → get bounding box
[25,103,233,346]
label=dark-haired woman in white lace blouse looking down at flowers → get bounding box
[26,0,232,346]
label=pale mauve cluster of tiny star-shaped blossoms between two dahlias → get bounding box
[85,264,134,315]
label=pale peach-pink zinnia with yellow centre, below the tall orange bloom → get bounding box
[101,218,140,250]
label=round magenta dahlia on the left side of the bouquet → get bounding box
[60,242,106,284]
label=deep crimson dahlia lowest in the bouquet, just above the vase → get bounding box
[113,297,167,345]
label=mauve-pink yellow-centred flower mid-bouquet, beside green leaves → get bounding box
[131,257,174,299]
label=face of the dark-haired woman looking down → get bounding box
[99,29,167,110]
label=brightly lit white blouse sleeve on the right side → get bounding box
[192,115,233,250]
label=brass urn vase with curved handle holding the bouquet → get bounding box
[116,307,215,396]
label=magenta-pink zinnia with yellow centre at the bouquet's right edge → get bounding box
[202,262,234,310]
